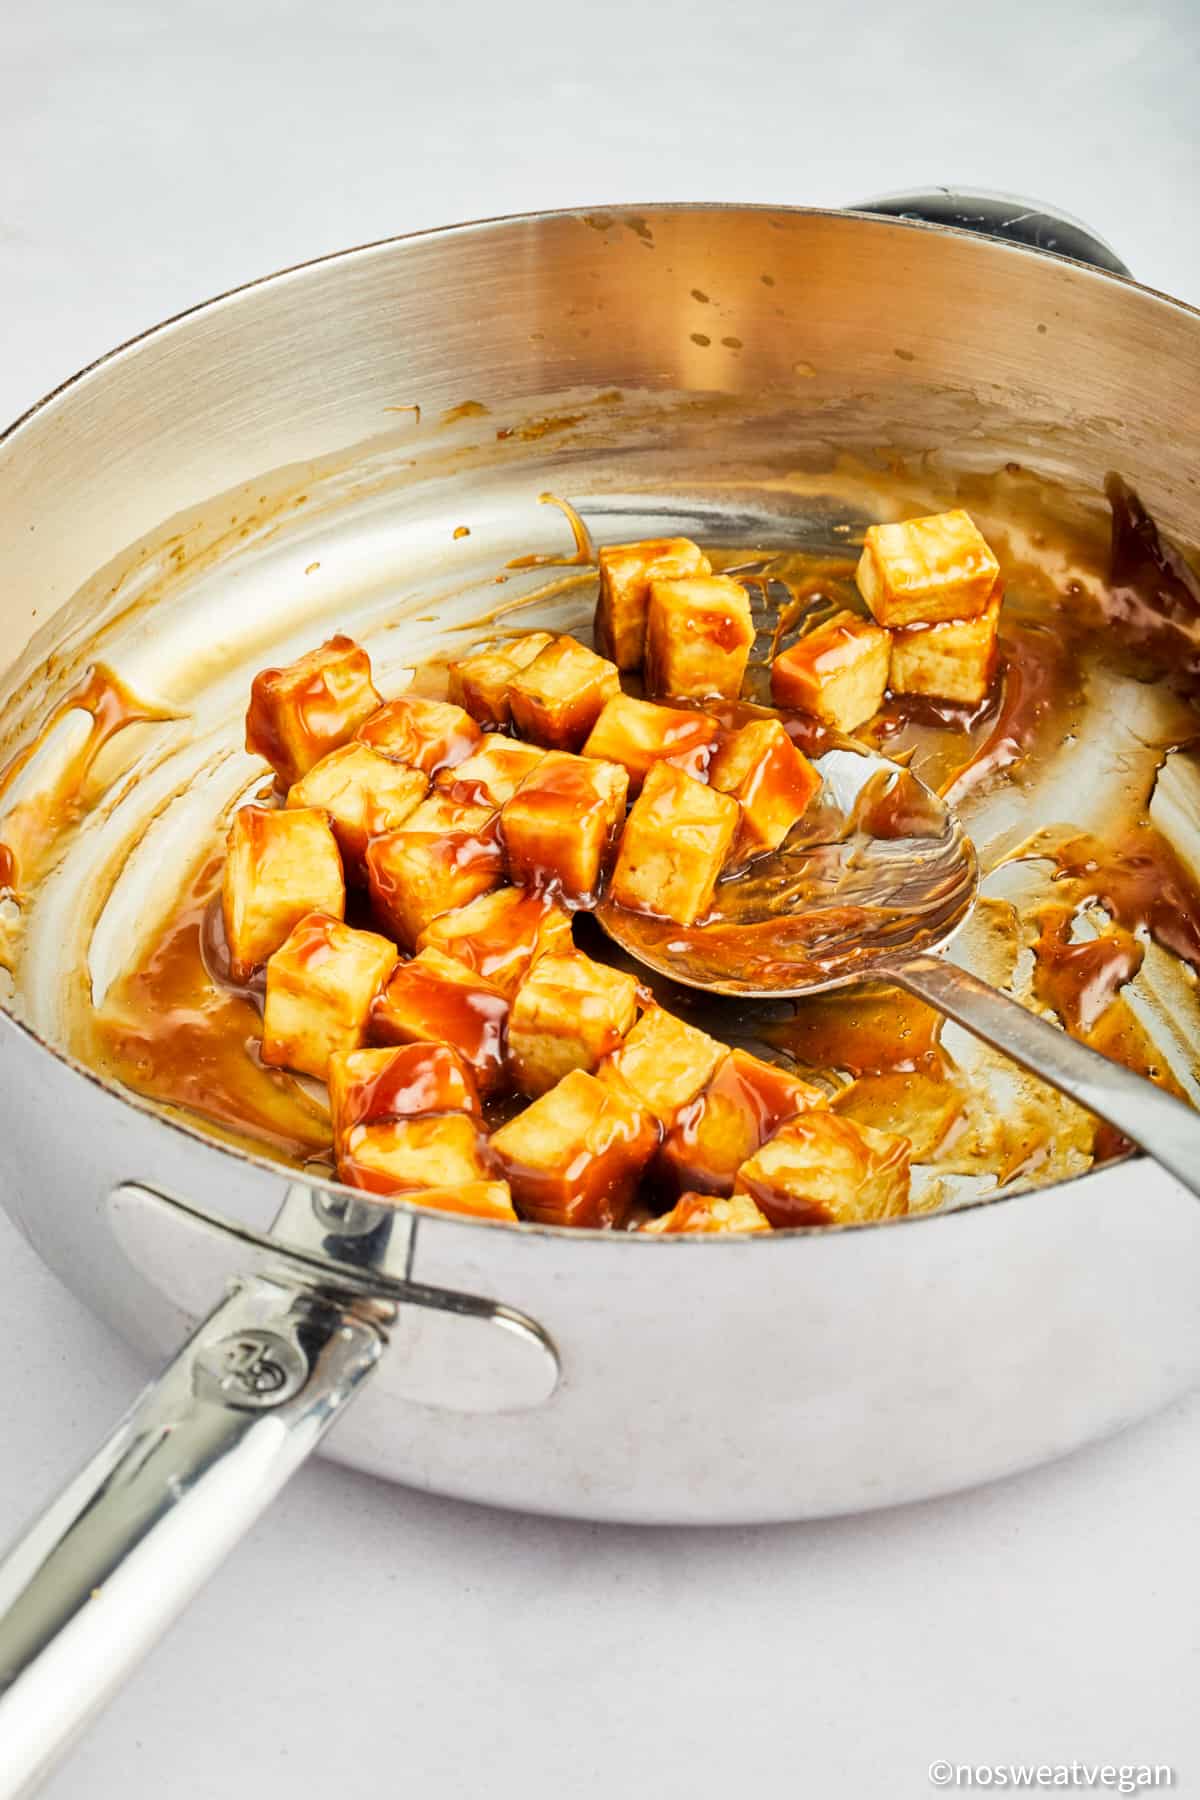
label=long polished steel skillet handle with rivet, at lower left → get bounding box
[0,1276,383,1800]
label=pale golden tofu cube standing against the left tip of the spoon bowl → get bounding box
[608,763,741,925]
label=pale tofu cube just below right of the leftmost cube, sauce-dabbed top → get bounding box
[263,913,396,1080]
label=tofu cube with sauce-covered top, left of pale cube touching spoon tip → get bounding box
[500,751,630,905]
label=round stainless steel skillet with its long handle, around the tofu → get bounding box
[0,207,1200,1793]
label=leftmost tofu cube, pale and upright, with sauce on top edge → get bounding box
[221,806,345,981]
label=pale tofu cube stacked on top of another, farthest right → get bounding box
[856,509,1000,626]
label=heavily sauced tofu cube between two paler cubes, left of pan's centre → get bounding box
[371,947,509,1094]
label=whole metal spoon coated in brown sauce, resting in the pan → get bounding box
[596,751,1200,1197]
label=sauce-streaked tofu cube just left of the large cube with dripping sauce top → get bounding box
[367,794,504,949]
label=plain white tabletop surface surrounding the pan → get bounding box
[0,0,1200,1800]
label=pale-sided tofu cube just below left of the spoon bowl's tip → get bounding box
[509,950,637,1094]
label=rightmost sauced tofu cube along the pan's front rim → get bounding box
[734,1112,909,1229]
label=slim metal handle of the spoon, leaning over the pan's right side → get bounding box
[889,956,1200,1197]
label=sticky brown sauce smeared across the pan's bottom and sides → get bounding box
[9,470,1200,1204]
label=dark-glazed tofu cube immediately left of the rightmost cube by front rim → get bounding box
[655,1049,826,1193]
